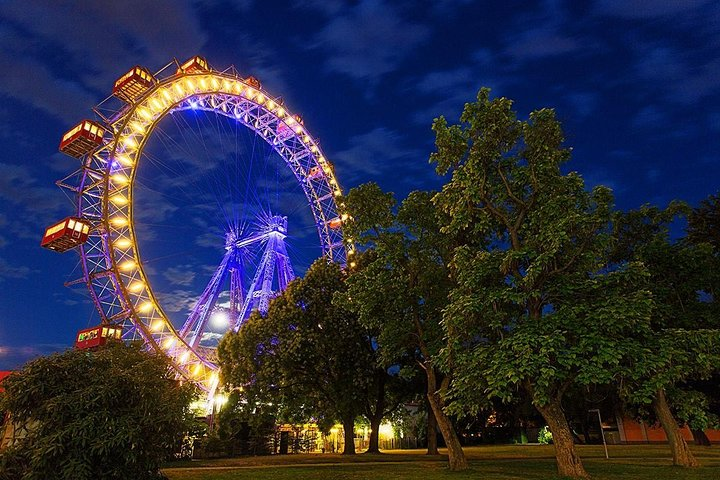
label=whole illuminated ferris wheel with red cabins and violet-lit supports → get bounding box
[42,56,354,393]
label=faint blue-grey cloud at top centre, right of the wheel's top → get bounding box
[313,0,430,85]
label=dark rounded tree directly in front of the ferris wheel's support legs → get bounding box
[218,258,375,454]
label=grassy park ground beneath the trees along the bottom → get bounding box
[163,445,720,480]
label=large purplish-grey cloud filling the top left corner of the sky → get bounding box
[0,0,206,120]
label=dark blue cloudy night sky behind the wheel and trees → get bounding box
[0,0,720,368]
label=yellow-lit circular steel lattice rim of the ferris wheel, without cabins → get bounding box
[58,61,353,392]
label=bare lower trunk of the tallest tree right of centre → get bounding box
[537,398,590,478]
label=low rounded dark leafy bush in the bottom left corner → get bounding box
[3,342,195,480]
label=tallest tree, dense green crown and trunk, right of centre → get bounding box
[431,89,652,478]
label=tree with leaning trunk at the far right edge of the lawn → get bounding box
[614,202,720,467]
